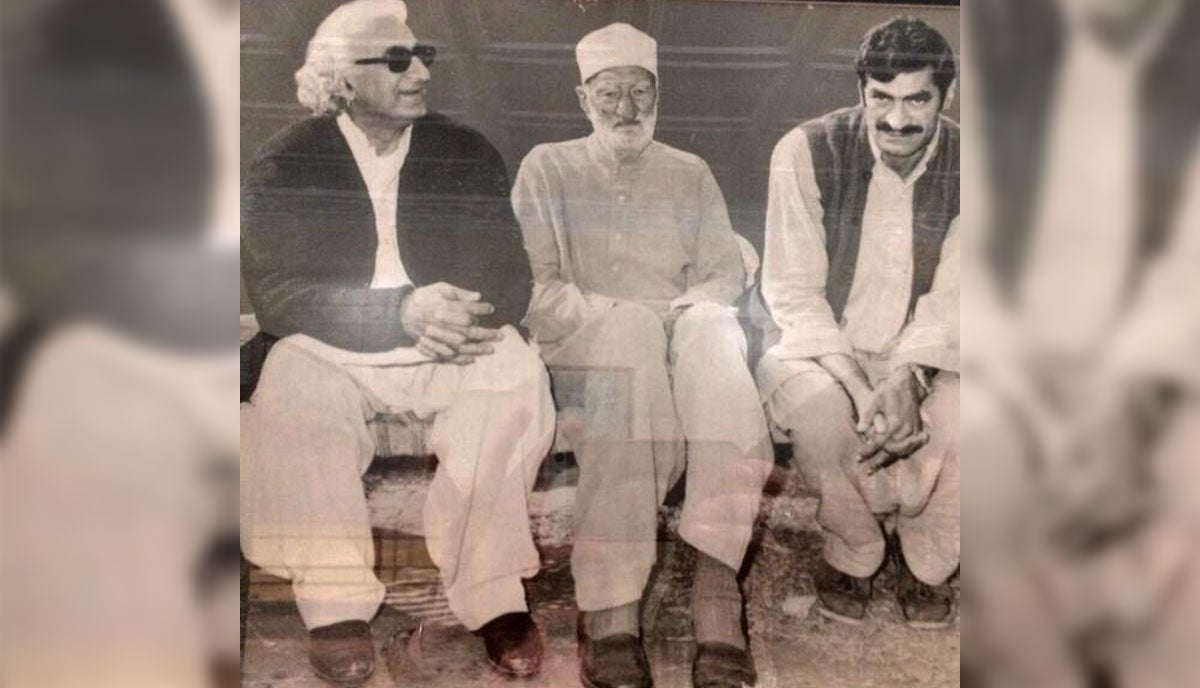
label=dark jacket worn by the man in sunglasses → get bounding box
[241,115,533,352]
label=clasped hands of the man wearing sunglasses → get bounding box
[400,282,502,365]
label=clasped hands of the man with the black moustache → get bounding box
[857,367,929,473]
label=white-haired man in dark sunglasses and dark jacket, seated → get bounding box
[241,0,554,686]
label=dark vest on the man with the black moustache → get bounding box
[802,107,959,321]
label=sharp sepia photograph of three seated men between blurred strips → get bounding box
[241,0,959,688]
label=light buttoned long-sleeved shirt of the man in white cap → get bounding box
[512,134,745,342]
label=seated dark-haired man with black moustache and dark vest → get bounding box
[758,18,959,626]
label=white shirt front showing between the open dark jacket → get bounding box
[337,113,413,289]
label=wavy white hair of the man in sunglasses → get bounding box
[295,0,408,115]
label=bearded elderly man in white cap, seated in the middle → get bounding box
[512,24,772,688]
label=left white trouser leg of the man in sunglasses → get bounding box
[241,340,384,629]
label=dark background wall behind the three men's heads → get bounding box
[241,0,959,307]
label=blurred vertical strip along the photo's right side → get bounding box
[961,0,1200,687]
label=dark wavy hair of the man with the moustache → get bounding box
[854,17,958,104]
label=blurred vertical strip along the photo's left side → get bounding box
[0,0,239,687]
